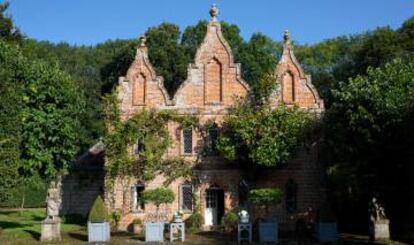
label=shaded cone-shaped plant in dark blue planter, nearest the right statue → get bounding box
[316,202,338,242]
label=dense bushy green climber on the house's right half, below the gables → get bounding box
[217,94,310,167]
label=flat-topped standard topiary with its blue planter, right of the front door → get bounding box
[249,188,283,242]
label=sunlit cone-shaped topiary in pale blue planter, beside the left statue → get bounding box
[88,196,111,242]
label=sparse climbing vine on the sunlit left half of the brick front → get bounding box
[105,93,197,183]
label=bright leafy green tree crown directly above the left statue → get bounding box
[21,61,85,180]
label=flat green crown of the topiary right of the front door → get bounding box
[249,188,283,206]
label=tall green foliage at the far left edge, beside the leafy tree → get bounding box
[0,40,24,202]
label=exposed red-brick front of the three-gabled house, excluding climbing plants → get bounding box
[63,5,324,232]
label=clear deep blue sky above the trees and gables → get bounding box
[5,0,414,45]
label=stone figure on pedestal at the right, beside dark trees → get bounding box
[368,197,390,241]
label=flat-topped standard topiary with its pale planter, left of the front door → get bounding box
[142,187,175,242]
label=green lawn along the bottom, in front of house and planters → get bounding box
[0,208,411,245]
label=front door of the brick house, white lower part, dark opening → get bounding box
[204,189,224,226]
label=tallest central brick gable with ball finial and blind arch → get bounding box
[173,7,250,110]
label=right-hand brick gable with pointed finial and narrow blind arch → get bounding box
[271,31,324,112]
